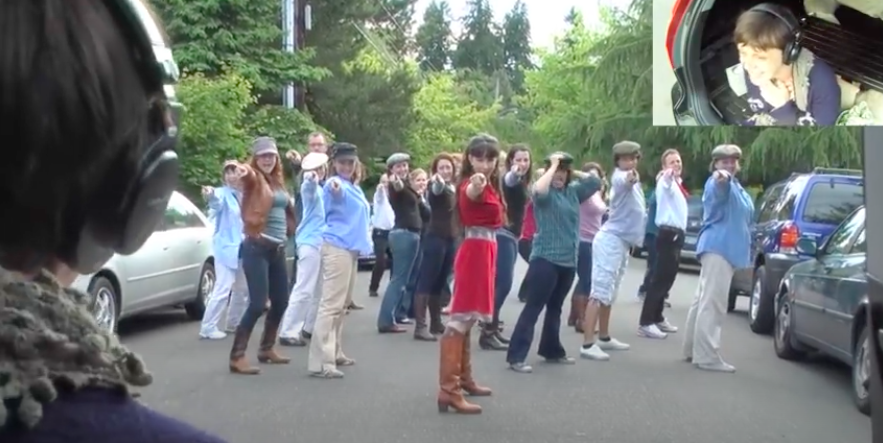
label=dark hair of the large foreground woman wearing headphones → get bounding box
[0,0,159,270]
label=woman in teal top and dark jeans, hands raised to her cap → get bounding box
[506,152,601,373]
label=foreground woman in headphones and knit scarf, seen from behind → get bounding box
[0,0,231,443]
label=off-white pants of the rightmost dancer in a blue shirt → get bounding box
[684,253,735,365]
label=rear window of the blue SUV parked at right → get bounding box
[803,182,865,225]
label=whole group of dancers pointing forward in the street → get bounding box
[200,133,753,414]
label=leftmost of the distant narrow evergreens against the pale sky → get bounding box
[415,1,453,71]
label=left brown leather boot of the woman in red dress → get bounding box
[437,328,481,414]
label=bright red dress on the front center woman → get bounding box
[449,181,503,321]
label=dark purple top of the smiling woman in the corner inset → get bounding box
[743,57,840,126]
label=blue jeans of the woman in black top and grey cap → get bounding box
[377,229,420,328]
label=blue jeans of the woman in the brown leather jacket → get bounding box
[239,238,288,331]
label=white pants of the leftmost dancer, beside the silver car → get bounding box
[199,263,248,334]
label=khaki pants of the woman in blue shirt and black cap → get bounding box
[307,243,358,372]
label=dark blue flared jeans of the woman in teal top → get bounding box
[506,258,576,364]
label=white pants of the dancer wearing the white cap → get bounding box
[279,245,322,338]
